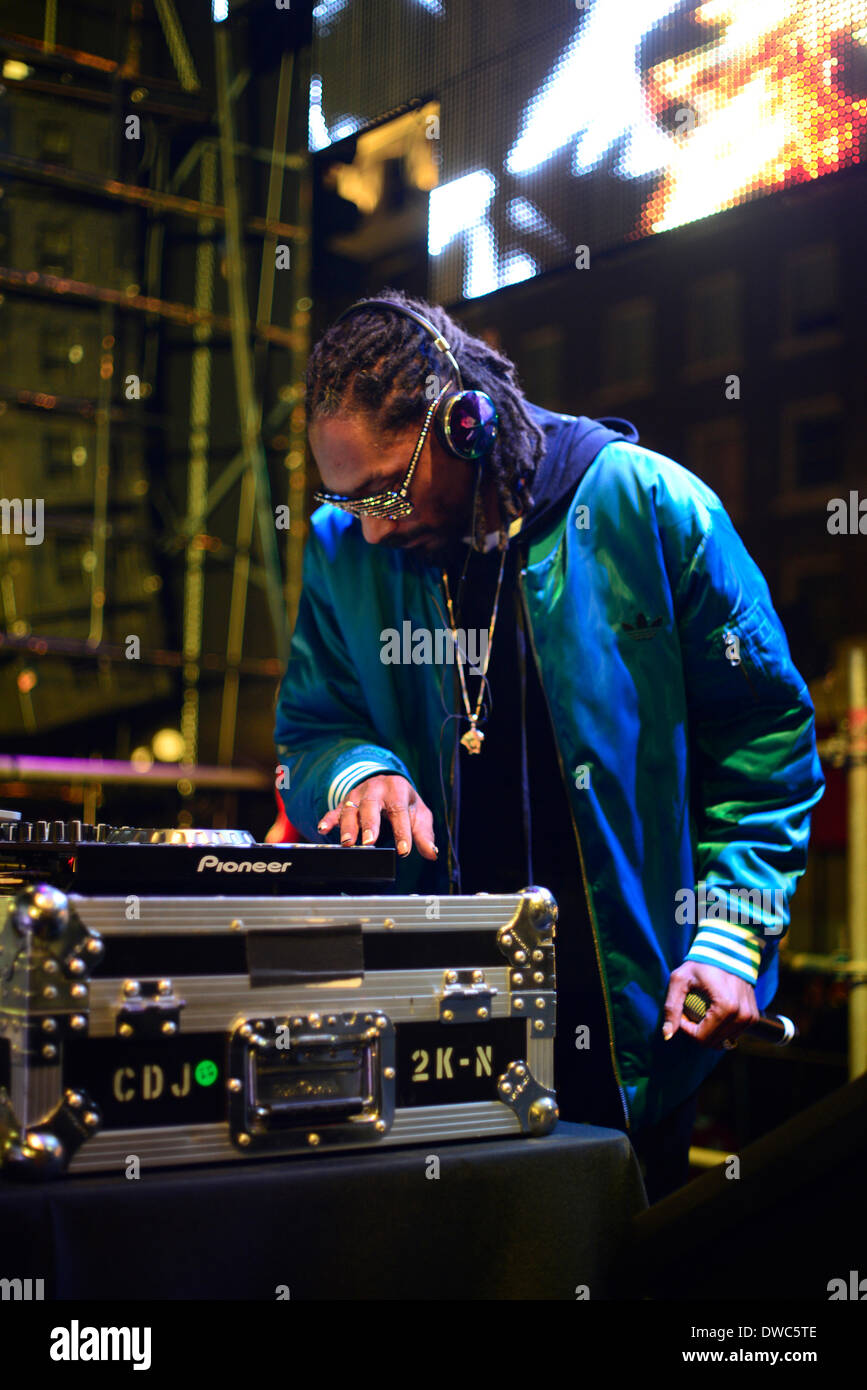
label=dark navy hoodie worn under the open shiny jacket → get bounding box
[449,406,638,1127]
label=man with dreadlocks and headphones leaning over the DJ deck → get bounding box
[275,291,824,1201]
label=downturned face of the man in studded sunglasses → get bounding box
[308,414,475,563]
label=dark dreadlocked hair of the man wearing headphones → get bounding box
[306,289,545,549]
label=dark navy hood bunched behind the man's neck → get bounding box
[520,400,638,537]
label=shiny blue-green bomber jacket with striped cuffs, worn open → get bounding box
[275,406,824,1130]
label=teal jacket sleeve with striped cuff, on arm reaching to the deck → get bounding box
[274,527,413,840]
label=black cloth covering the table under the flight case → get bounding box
[0,1123,646,1301]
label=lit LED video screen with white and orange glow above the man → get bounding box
[310,0,867,303]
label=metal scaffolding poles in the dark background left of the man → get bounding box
[0,0,311,785]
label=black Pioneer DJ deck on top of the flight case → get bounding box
[0,812,395,897]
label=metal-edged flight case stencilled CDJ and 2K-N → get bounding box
[0,837,557,1177]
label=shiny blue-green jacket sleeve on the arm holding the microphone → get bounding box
[674,487,824,984]
